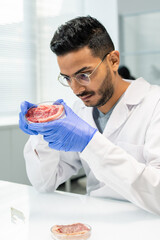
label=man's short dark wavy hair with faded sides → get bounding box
[50,16,114,58]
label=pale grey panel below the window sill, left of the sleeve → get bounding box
[0,125,29,184]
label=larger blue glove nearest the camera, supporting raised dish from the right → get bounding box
[28,100,97,152]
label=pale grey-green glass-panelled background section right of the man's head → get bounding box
[118,0,160,85]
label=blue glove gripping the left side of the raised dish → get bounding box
[19,101,38,135]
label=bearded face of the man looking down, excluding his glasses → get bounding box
[57,47,114,107]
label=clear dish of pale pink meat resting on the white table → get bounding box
[51,223,91,240]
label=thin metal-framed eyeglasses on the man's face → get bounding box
[58,53,109,87]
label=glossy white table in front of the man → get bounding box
[0,181,160,240]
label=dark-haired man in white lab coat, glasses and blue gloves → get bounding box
[20,16,160,214]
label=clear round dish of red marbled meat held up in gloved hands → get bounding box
[25,101,65,123]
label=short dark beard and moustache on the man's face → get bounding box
[77,69,114,108]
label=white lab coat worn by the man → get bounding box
[24,78,160,214]
